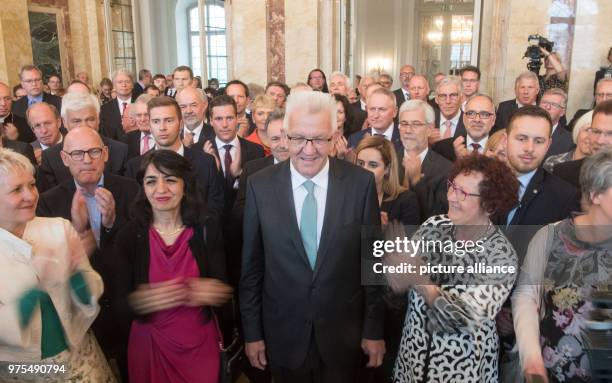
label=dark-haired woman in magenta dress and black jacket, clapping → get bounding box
[113,150,232,383]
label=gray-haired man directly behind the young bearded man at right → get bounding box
[491,71,540,133]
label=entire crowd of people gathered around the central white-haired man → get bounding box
[0,55,612,383]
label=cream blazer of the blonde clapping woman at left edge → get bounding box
[0,217,103,362]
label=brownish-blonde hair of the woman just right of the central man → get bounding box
[355,136,407,201]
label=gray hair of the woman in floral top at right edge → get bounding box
[580,149,612,204]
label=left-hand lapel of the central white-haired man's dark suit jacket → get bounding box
[274,161,310,269]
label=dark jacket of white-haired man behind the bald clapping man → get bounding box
[36,137,127,192]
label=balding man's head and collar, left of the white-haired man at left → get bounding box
[26,102,63,165]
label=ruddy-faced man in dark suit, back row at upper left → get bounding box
[13,65,62,124]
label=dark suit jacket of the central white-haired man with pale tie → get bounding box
[240,159,384,369]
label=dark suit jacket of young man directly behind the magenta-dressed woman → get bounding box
[125,147,224,216]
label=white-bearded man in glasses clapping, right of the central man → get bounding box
[397,100,452,221]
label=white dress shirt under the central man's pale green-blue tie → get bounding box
[289,160,329,248]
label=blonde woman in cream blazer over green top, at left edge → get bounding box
[0,148,115,382]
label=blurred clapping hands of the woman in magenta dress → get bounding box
[128,278,188,315]
